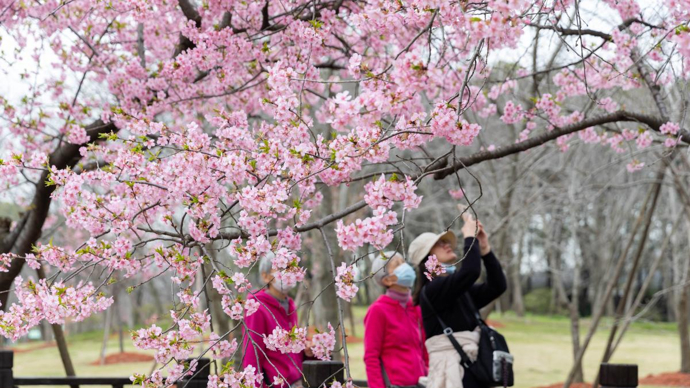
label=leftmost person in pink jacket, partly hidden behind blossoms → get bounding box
[242,253,312,388]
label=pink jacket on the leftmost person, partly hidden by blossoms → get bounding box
[242,290,304,388]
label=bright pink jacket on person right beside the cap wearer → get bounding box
[364,295,429,388]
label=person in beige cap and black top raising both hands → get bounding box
[408,213,507,388]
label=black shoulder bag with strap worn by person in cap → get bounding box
[422,289,514,388]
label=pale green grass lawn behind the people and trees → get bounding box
[8,307,680,388]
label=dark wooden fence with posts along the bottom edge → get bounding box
[0,350,638,388]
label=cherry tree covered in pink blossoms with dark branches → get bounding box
[0,0,690,387]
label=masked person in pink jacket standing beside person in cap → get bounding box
[364,252,429,388]
